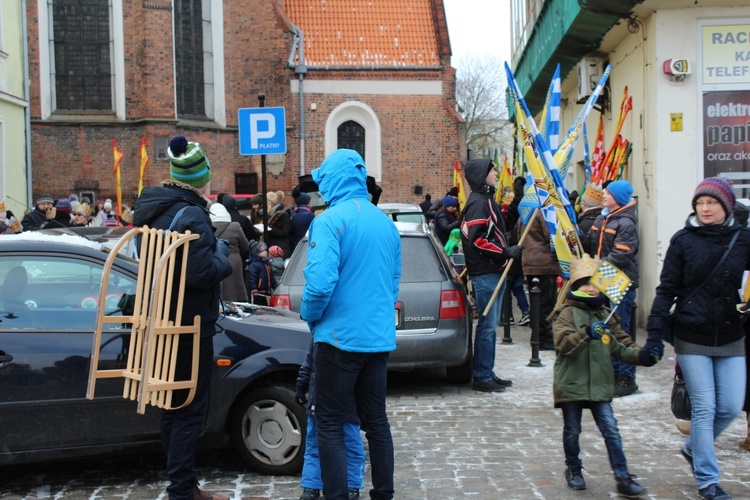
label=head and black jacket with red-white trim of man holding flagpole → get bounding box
[461,158,508,276]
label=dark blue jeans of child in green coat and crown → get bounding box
[560,401,628,477]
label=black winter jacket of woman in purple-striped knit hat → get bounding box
[647,214,750,346]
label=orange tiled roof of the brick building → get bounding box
[284,0,440,67]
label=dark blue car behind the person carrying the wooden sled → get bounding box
[0,231,310,475]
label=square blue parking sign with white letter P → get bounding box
[238,107,286,155]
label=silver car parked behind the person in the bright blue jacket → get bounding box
[271,222,473,383]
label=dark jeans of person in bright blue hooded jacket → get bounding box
[313,343,394,500]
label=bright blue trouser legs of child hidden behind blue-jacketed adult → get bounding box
[299,416,365,490]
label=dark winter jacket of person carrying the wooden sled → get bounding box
[133,181,232,337]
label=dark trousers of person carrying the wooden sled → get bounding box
[161,337,214,500]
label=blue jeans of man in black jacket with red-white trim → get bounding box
[471,273,507,382]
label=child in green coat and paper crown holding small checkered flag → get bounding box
[552,255,661,498]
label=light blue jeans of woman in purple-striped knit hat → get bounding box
[677,354,746,488]
